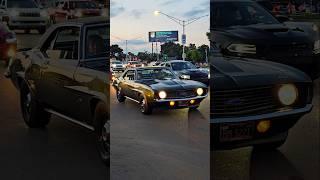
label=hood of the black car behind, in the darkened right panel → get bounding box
[224,24,310,44]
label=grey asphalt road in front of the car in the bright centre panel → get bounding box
[110,80,210,180]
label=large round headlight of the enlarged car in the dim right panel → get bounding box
[278,84,298,106]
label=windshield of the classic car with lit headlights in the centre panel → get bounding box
[138,68,176,80]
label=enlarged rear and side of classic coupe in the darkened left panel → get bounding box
[9,18,110,164]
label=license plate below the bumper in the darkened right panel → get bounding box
[220,123,254,142]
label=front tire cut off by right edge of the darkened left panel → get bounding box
[94,103,110,166]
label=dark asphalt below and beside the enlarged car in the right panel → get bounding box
[211,80,320,180]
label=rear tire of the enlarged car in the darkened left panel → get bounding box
[20,83,51,128]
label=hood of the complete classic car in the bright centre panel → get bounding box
[139,79,206,91]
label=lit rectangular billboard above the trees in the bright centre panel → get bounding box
[149,31,179,42]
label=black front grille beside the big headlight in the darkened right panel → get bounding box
[210,87,278,117]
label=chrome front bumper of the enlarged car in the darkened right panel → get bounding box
[210,104,313,124]
